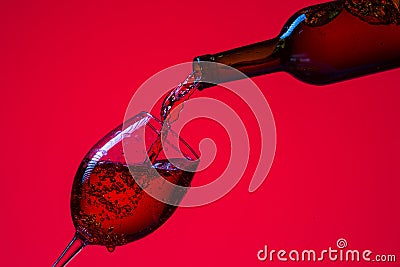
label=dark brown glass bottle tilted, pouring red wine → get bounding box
[193,0,400,86]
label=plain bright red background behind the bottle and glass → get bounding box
[0,0,400,267]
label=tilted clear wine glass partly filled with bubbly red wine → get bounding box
[53,112,199,267]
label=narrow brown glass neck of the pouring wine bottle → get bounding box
[193,37,283,89]
